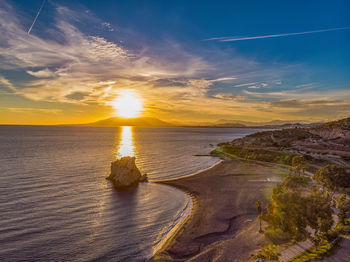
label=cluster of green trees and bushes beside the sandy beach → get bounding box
[256,156,350,261]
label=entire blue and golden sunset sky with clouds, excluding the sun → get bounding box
[0,0,350,124]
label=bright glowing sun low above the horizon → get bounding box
[112,91,143,118]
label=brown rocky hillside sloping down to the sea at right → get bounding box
[215,118,350,163]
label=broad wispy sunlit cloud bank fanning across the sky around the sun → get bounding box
[0,0,348,123]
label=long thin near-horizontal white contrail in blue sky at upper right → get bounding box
[204,26,350,42]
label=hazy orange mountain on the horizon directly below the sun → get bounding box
[81,117,172,127]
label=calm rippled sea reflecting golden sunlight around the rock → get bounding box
[0,126,257,261]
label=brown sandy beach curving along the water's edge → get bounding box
[150,159,281,261]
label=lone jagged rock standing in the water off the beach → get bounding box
[108,156,147,189]
